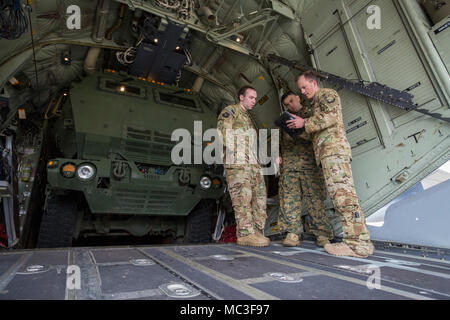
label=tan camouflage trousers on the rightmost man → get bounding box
[321,156,373,255]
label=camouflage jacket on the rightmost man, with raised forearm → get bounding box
[305,89,352,165]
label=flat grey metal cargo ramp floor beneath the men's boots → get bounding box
[0,241,450,302]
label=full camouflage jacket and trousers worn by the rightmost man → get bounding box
[305,89,373,255]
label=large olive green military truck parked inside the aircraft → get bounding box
[38,70,225,247]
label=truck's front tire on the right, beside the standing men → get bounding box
[185,202,211,244]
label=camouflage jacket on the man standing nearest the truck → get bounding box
[217,104,259,169]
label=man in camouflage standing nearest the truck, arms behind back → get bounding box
[217,86,270,247]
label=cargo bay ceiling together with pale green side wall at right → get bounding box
[0,0,450,214]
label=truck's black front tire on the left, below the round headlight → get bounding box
[37,195,77,248]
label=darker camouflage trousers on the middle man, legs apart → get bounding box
[278,167,333,239]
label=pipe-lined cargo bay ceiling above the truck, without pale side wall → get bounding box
[0,0,314,109]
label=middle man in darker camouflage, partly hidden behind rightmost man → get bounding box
[278,92,333,247]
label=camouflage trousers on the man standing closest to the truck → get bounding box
[226,165,267,237]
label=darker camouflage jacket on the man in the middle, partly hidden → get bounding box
[280,107,316,171]
